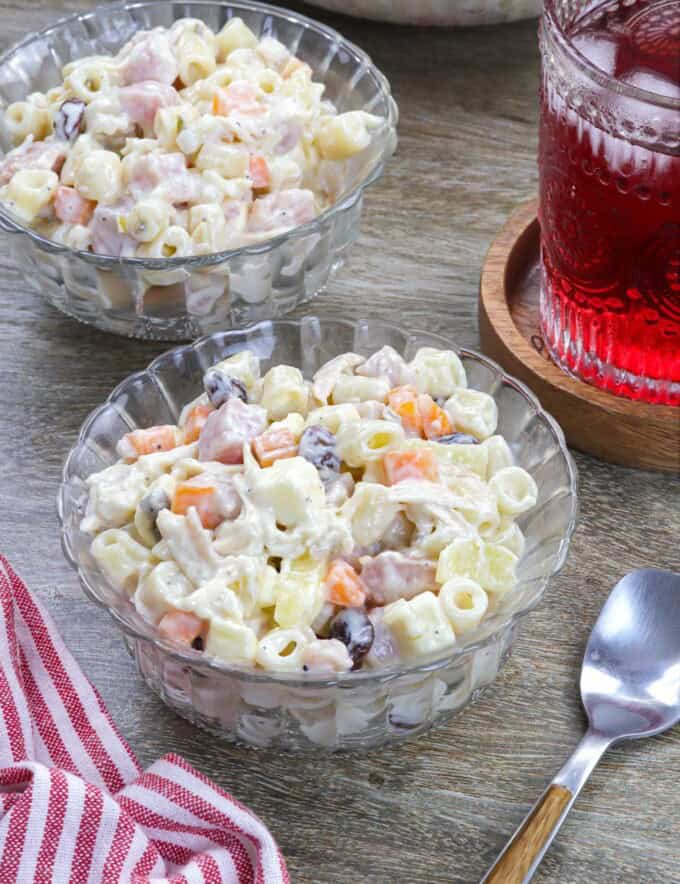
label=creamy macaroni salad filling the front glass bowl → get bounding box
[81,347,537,673]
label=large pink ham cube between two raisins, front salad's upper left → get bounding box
[198,396,267,464]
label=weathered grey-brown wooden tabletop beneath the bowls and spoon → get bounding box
[0,0,680,884]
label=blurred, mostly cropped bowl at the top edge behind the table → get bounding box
[307,0,541,26]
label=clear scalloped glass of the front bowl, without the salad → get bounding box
[58,316,577,751]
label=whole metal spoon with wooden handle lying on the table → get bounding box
[481,568,680,884]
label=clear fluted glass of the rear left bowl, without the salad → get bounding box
[0,0,398,340]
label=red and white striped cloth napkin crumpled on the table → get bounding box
[0,556,288,884]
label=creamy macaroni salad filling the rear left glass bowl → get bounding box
[0,18,382,258]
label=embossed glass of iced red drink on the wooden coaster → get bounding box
[539,0,680,405]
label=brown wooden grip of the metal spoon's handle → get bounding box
[484,783,574,884]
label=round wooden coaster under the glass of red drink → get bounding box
[479,200,680,472]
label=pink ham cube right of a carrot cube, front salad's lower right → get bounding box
[361,551,437,605]
